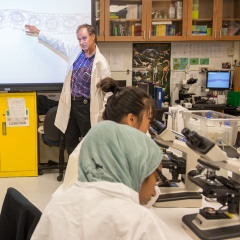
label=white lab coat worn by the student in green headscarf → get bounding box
[31,181,174,240]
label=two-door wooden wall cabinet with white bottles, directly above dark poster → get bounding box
[105,0,188,42]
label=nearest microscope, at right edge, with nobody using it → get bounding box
[182,128,240,240]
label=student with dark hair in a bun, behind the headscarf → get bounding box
[53,78,155,195]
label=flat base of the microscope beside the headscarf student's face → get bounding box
[153,192,202,208]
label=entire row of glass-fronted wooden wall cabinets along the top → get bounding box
[93,0,240,42]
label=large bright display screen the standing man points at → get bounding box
[0,0,92,91]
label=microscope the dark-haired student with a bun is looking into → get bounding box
[150,119,202,208]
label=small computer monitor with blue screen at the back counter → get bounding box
[206,70,231,91]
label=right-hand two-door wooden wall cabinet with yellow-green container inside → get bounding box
[187,0,240,40]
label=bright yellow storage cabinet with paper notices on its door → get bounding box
[0,92,38,177]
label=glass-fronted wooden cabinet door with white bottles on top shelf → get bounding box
[146,0,187,41]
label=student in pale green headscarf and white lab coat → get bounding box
[31,121,174,240]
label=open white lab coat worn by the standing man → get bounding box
[38,31,111,133]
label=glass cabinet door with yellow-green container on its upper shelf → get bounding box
[187,0,220,41]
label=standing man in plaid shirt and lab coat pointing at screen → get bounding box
[25,24,111,155]
